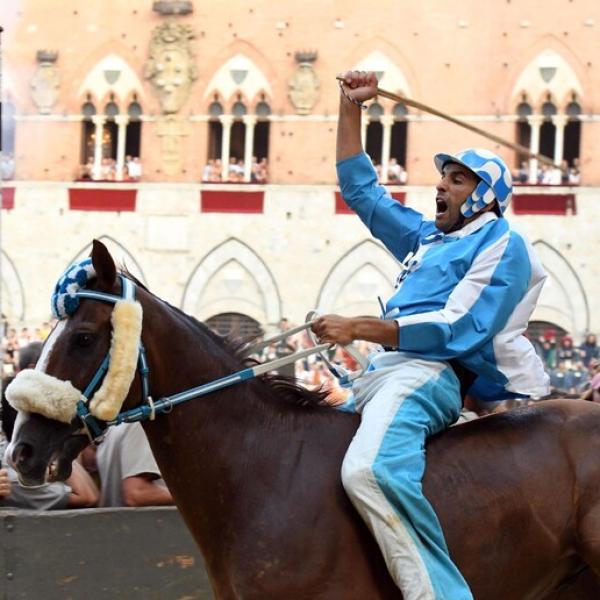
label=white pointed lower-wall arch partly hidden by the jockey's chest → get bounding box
[317,240,399,316]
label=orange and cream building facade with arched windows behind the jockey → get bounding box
[0,0,600,336]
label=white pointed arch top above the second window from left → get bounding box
[203,52,273,105]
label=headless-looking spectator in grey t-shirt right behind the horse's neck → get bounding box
[96,423,173,506]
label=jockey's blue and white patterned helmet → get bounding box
[433,148,512,218]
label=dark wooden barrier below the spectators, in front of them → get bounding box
[0,507,213,600]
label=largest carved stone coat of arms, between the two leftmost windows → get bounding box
[144,21,198,115]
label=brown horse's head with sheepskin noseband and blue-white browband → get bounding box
[6,240,141,486]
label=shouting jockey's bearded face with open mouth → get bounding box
[435,163,478,233]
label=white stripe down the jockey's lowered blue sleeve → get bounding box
[396,231,510,327]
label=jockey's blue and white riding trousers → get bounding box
[342,354,472,600]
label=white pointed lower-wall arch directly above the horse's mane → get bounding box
[181,238,281,324]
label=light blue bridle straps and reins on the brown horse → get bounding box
[77,275,367,442]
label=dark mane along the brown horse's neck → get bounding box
[119,266,329,408]
